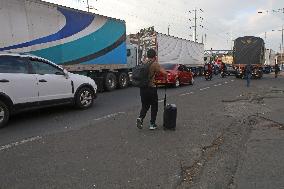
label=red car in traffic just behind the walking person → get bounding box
[155,64,194,87]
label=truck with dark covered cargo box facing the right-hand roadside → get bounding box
[233,36,265,78]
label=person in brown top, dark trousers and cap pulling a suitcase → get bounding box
[136,49,168,130]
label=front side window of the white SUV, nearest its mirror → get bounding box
[30,60,64,75]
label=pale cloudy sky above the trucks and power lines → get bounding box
[45,0,284,52]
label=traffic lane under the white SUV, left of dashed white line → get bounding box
[0,76,234,145]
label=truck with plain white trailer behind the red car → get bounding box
[128,27,204,66]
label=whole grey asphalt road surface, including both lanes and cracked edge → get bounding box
[0,75,284,189]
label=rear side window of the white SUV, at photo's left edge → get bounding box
[0,56,28,74]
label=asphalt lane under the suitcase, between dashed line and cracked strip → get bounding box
[0,74,244,188]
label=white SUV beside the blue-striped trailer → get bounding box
[0,53,97,128]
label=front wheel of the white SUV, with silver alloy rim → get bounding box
[75,87,94,109]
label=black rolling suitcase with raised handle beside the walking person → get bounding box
[163,86,177,130]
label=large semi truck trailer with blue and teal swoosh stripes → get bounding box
[0,0,136,91]
